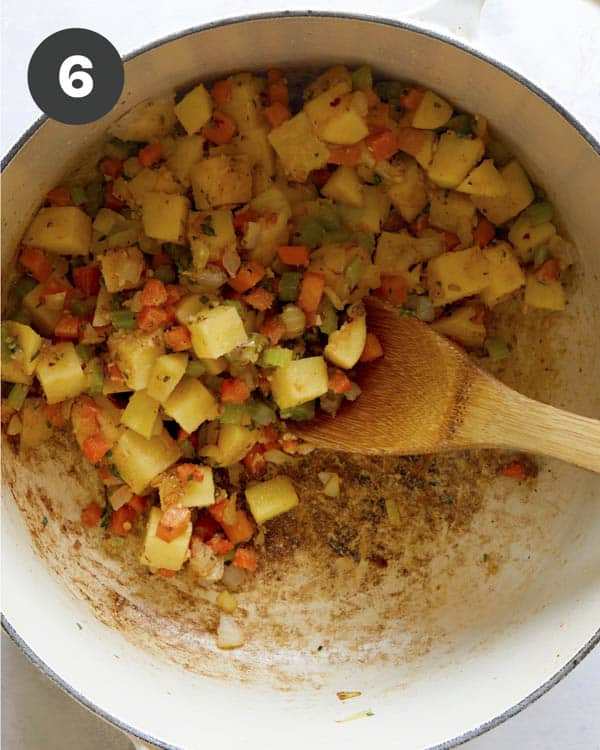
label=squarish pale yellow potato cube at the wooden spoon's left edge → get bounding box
[271,357,328,409]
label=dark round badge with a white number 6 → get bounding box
[27,29,124,125]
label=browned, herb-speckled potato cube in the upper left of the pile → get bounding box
[190,154,252,209]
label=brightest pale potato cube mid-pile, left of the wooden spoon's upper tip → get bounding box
[188,305,248,362]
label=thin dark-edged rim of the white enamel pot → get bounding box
[0,10,600,750]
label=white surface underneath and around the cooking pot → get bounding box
[0,0,600,750]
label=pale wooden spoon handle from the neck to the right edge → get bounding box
[455,377,600,474]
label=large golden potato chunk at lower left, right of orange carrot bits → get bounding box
[112,428,181,495]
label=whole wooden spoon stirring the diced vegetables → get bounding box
[294,300,600,473]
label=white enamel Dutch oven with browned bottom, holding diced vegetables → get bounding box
[2,14,600,750]
